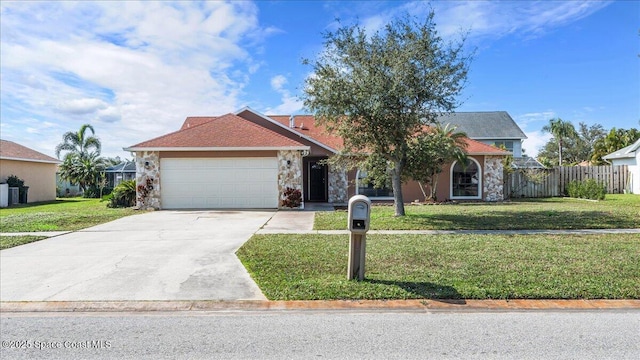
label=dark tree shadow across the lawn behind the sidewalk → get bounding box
[402,210,640,230]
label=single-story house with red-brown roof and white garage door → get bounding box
[124,108,510,209]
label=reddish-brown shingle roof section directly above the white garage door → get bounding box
[129,114,307,149]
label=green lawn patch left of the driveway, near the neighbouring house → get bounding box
[0,198,136,232]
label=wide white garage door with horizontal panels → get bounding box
[160,158,278,209]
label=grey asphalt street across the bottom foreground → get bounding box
[0,310,640,359]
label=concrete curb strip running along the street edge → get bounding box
[0,299,640,314]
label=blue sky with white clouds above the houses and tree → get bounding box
[0,0,640,158]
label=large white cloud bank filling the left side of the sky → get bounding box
[0,1,266,156]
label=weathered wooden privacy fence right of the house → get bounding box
[504,165,629,198]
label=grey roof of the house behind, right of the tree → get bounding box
[438,111,527,140]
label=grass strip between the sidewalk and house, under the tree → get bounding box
[314,194,640,230]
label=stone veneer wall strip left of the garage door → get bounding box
[136,151,160,210]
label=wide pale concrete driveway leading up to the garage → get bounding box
[0,211,275,301]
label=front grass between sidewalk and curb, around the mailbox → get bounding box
[237,234,640,300]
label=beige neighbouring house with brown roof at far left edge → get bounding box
[0,140,60,203]
